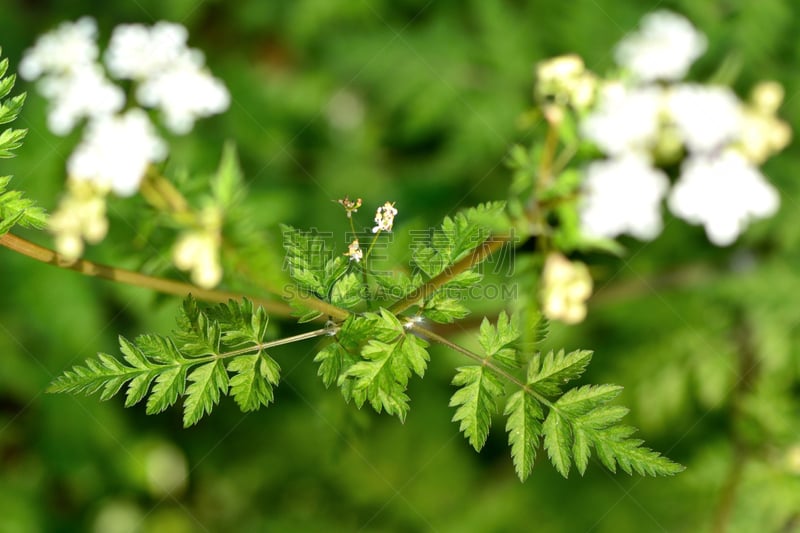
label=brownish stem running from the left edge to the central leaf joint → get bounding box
[0,233,292,316]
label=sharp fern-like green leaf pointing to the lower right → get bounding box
[450,313,683,481]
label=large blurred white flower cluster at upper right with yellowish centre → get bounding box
[580,11,791,246]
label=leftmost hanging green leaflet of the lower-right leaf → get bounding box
[450,365,503,451]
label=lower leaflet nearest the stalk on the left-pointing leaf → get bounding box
[228,353,280,412]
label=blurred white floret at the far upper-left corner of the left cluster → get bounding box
[19,17,98,80]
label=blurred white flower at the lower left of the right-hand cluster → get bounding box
[580,154,669,240]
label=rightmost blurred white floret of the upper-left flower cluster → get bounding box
[136,63,230,134]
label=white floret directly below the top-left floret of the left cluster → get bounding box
[39,63,125,135]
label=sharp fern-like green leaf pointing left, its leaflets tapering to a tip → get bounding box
[48,297,280,427]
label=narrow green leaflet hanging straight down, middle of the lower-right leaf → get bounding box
[504,390,544,481]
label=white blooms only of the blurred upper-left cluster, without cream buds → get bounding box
[20,17,229,196]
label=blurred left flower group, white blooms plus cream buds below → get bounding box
[19,17,230,272]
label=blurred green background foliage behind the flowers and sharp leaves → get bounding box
[0,0,800,533]
